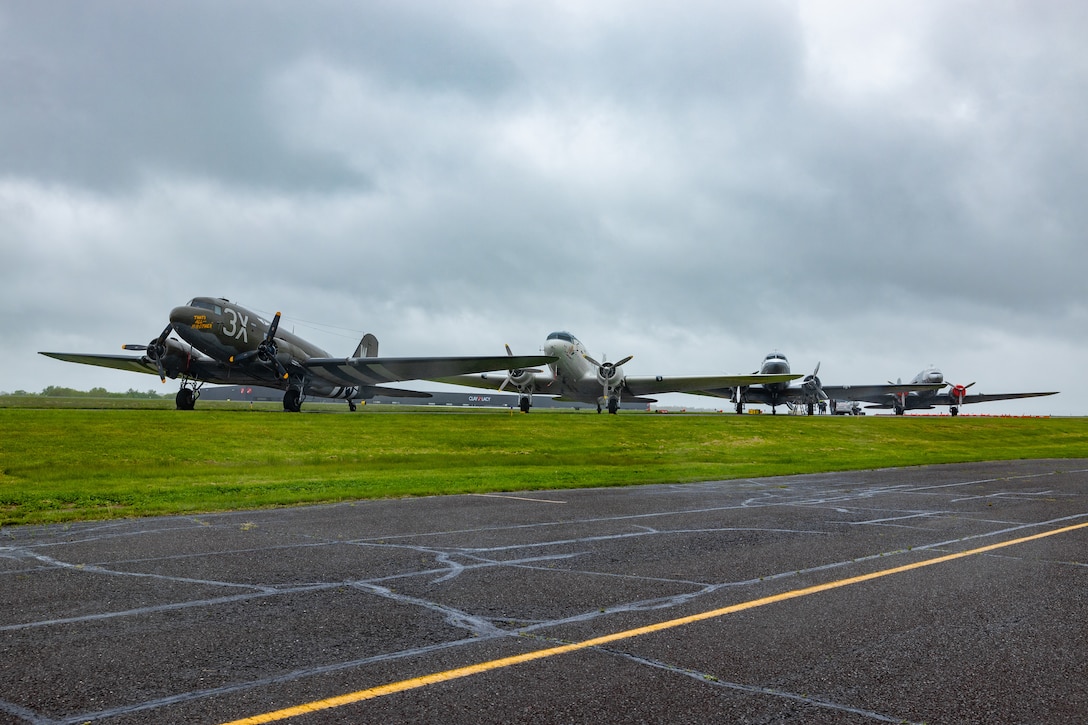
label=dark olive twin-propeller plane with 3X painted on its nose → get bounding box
[41,297,555,413]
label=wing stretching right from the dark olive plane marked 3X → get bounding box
[298,355,555,388]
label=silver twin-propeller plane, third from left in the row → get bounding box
[696,352,944,415]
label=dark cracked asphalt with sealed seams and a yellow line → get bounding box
[0,459,1088,725]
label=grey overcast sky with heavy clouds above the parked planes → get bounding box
[0,0,1088,415]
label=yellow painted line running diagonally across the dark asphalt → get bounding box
[223,521,1088,725]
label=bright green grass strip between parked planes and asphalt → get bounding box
[0,398,1088,525]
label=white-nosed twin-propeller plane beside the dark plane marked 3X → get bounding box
[431,332,801,415]
